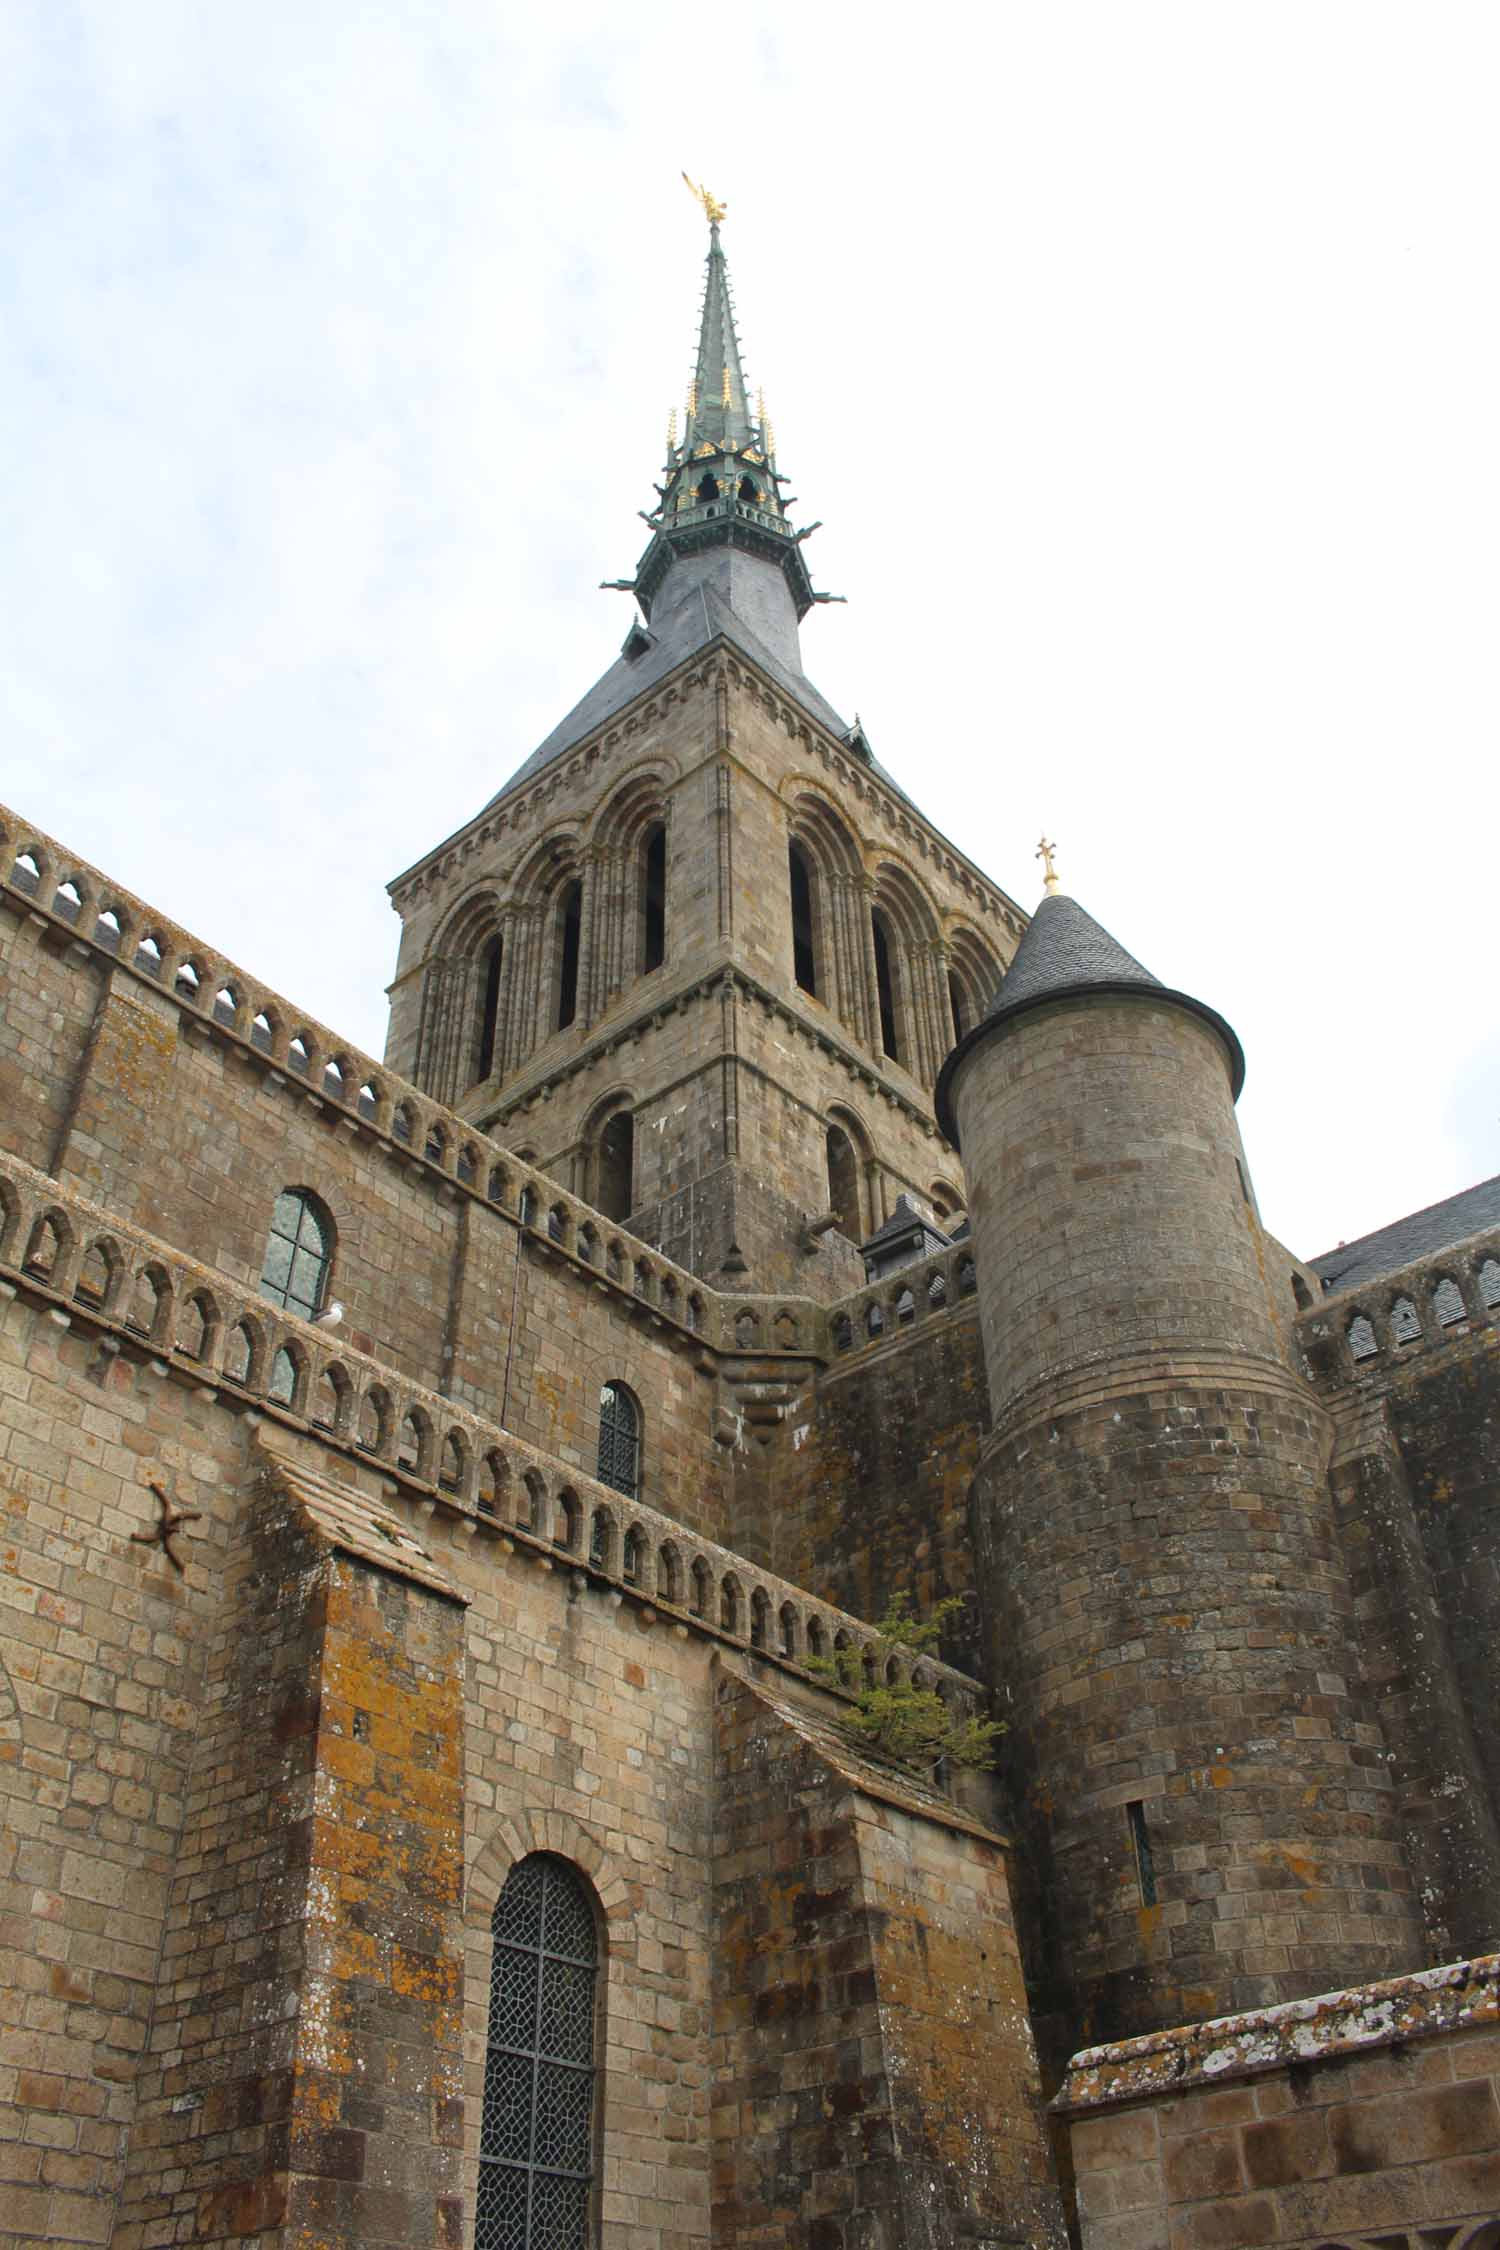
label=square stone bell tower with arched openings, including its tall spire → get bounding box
[387,198,1023,1298]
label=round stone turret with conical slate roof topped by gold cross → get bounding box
[938,868,1421,2043]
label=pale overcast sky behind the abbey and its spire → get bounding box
[0,0,1500,1253]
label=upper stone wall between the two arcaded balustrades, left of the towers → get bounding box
[0,886,722,1528]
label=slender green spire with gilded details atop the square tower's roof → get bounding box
[609,173,841,639]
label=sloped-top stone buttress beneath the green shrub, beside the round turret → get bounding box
[713,1676,1066,2250]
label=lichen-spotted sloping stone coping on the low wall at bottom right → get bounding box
[1052,1953,1500,2117]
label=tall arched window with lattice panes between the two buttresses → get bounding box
[475,1852,598,2250]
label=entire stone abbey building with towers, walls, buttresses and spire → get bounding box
[0,198,1500,2250]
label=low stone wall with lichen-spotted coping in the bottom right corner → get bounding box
[1052,1955,1500,2250]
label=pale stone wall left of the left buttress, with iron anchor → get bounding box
[0,1294,245,2250]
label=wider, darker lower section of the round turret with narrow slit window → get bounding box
[976,1382,1424,2052]
